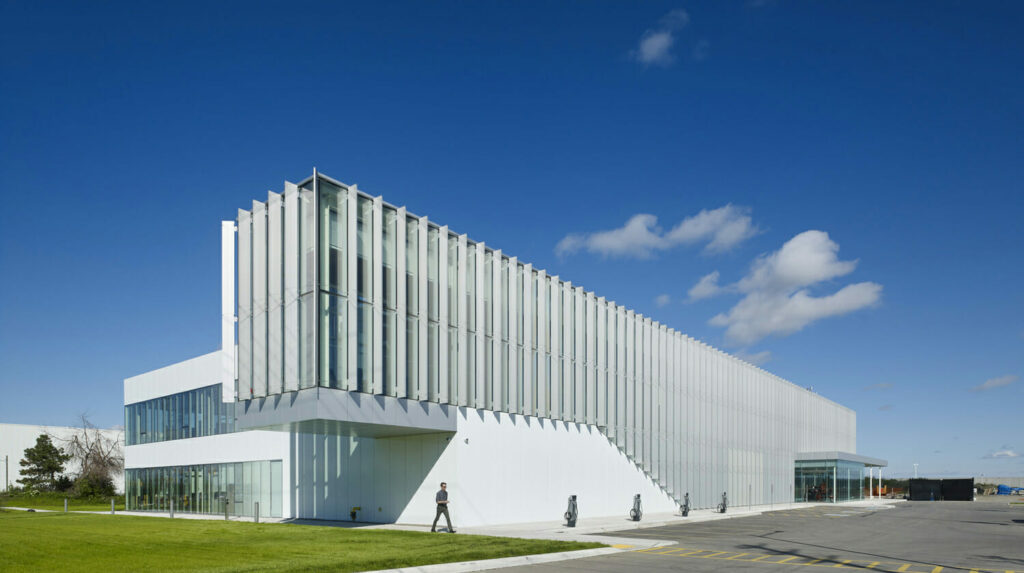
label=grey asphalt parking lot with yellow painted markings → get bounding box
[512,496,1024,573]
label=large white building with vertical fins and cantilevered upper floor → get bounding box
[125,173,885,526]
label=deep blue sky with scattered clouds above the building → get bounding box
[0,1,1024,476]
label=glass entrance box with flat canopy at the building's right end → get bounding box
[794,451,888,503]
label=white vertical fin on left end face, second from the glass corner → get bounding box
[266,191,285,394]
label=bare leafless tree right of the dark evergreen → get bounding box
[50,413,125,495]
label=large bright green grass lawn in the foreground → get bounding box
[0,511,603,573]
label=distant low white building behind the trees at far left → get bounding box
[0,424,125,491]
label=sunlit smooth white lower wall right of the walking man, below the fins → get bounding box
[450,408,677,526]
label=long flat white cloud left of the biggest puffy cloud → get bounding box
[555,205,760,259]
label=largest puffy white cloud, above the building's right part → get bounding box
[709,230,882,345]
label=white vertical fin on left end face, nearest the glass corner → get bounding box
[282,183,299,392]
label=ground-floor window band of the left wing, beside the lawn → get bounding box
[125,459,282,518]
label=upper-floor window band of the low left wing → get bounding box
[125,384,234,446]
